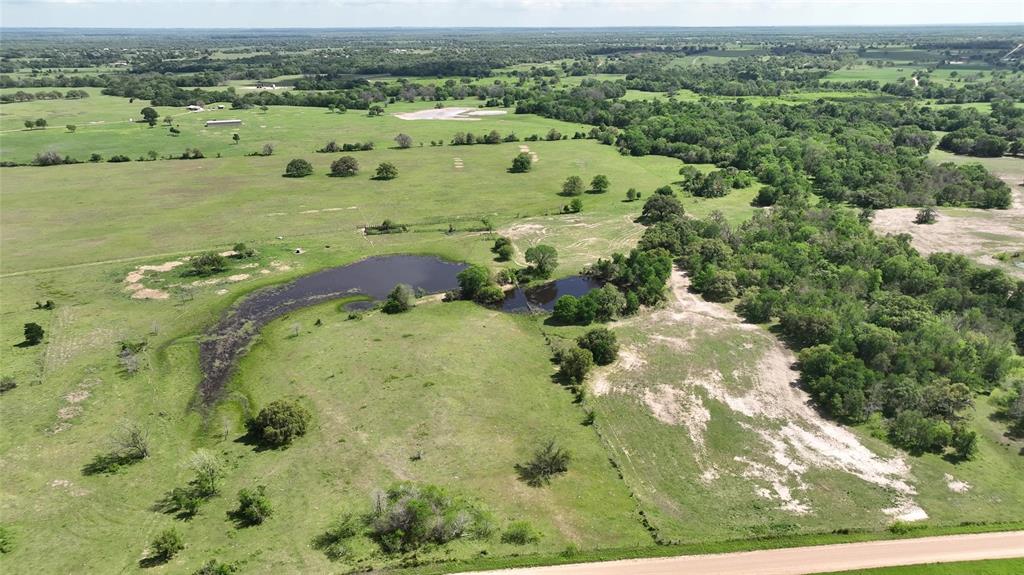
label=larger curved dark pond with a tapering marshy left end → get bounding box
[199,256,466,406]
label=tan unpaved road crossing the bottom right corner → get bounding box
[466,531,1024,575]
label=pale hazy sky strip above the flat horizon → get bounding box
[0,0,1024,28]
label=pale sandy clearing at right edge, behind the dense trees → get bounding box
[871,177,1024,278]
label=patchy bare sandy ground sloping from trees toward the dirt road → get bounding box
[592,271,928,521]
